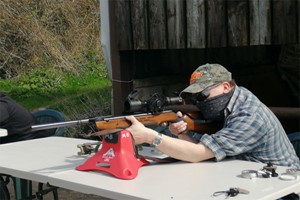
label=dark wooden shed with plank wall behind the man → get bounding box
[100,0,300,132]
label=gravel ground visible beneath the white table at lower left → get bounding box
[8,181,111,200]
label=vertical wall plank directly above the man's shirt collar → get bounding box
[227,0,248,47]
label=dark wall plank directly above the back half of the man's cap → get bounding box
[207,0,227,47]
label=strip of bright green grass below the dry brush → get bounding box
[0,66,111,115]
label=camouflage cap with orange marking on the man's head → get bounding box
[181,64,232,93]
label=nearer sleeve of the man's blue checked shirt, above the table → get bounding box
[200,112,266,161]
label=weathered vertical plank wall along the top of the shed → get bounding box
[112,0,300,50]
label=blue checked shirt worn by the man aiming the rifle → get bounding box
[200,86,300,168]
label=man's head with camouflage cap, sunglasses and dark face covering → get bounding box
[180,64,235,121]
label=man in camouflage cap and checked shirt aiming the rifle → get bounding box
[126,64,300,168]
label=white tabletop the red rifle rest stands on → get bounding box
[0,137,300,200]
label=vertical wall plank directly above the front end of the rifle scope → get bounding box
[131,0,149,49]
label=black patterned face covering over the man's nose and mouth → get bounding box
[196,90,234,121]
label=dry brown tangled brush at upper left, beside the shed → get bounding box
[0,0,103,78]
